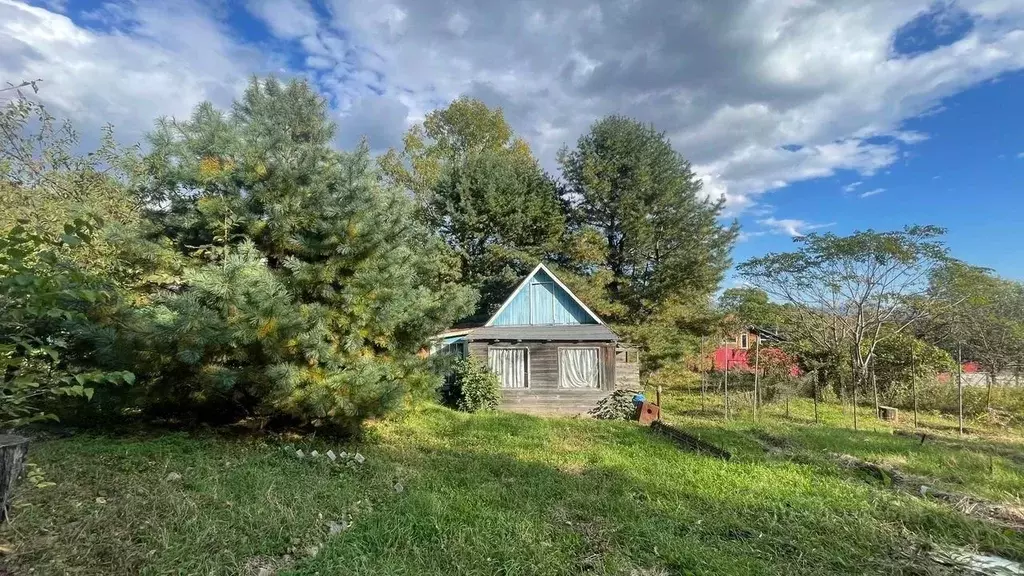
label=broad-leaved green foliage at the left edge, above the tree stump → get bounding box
[0,220,134,427]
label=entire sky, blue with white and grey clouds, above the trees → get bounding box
[6,0,1024,282]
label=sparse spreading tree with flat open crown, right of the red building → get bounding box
[737,225,951,384]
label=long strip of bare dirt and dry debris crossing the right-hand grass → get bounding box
[833,454,1024,533]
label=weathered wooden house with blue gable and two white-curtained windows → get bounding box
[432,263,639,413]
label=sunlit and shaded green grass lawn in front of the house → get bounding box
[0,397,1024,575]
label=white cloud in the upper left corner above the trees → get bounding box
[0,0,271,141]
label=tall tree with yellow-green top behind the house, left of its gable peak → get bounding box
[379,97,565,316]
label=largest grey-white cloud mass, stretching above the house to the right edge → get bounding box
[321,0,1024,213]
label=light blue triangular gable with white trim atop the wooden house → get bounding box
[493,270,598,326]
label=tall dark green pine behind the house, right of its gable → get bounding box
[559,116,737,324]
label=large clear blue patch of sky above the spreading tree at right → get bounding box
[734,73,1024,280]
